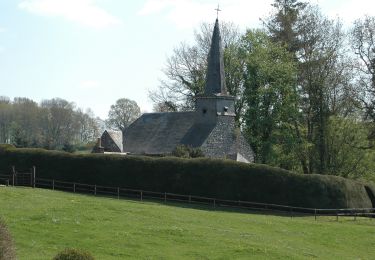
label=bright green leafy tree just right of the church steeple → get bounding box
[243,30,298,165]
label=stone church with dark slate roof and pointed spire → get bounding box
[122,19,254,162]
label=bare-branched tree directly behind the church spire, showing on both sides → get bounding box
[149,22,243,114]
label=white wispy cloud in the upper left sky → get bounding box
[18,0,121,28]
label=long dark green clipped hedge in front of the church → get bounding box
[0,146,372,208]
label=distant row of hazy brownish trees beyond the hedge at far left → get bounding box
[0,97,101,151]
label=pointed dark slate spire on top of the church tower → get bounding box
[204,19,227,96]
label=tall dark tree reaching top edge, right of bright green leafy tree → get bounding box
[266,0,350,173]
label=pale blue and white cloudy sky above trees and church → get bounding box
[0,0,375,119]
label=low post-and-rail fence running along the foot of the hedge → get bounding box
[0,174,375,220]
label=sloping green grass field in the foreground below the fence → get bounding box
[0,187,375,260]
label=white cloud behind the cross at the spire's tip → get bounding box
[138,0,273,28]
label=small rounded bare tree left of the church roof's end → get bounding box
[106,98,141,131]
